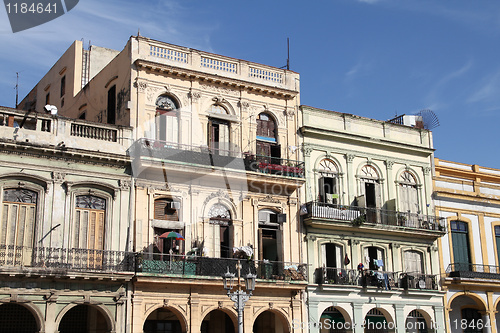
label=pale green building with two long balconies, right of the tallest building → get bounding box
[300,106,446,332]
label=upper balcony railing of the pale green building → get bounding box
[306,201,446,232]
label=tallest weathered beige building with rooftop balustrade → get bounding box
[20,36,307,332]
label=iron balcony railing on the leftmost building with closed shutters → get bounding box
[0,245,135,274]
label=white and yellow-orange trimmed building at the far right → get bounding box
[434,159,500,333]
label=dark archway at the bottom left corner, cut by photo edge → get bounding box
[0,303,39,333]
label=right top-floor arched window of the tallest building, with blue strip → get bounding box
[256,112,281,164]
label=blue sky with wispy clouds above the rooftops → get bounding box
[0,0,500,168]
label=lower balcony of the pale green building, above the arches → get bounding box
[315,267,438,290]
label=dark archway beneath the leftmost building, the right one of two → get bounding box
[59,305,111,333]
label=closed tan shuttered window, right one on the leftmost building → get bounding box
[73,194,106,250]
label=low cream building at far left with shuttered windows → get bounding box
[0,108,134,333]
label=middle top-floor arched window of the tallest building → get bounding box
[208,104,231,156]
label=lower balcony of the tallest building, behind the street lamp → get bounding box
[137,253,307,282]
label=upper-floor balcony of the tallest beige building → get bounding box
[129,138,304,178]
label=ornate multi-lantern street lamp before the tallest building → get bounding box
[222,260,257,333]
